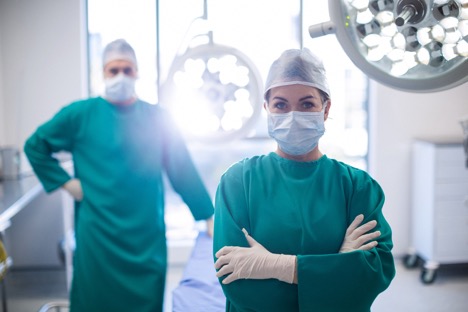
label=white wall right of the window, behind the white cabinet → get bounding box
[369,82,468,255]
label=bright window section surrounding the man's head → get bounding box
[88,0,158,103]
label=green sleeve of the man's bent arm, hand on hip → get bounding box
[24,107,74,193]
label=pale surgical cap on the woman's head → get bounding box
[263,48,330,99]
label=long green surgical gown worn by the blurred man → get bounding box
[24,97,214,312]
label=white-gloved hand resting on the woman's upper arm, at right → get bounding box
[340,214,380,253]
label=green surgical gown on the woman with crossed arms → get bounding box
[213,153,395,312]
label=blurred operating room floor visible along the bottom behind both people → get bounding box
[6,261,468,312]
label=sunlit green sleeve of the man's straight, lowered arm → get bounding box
[162,113,214,220]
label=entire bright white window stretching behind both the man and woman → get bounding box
[88,0,367,239]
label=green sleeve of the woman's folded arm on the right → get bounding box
[297,172,395,312]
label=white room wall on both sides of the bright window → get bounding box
[0,0,468,256]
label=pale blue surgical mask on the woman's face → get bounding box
[267,108,325,156]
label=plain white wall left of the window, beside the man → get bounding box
[0,0,87,155]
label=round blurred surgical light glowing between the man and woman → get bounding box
[162,43,263,142]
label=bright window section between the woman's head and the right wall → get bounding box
[302,0,368,170]
